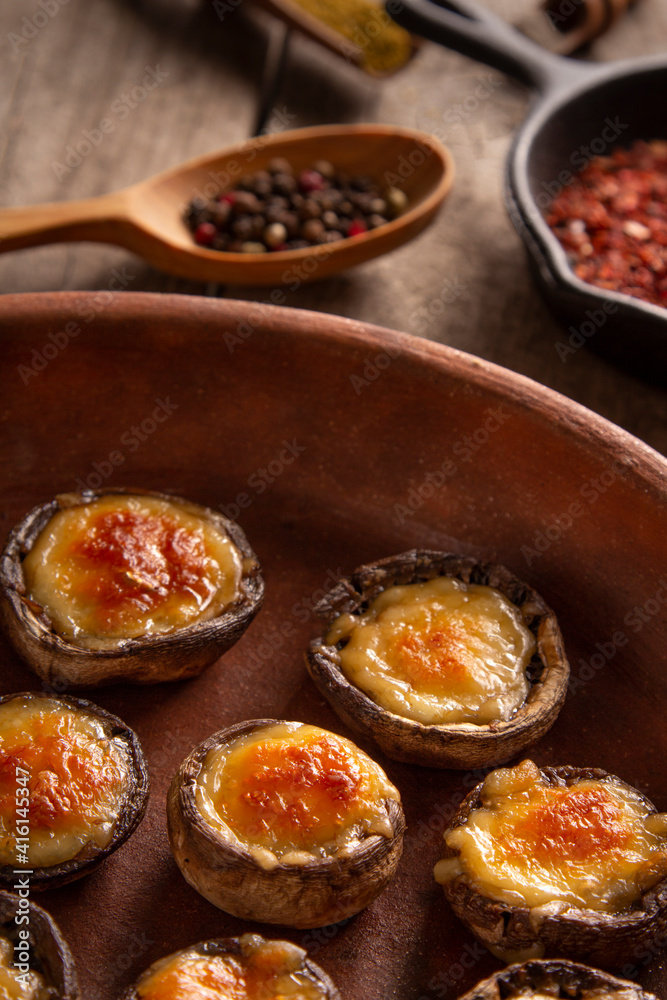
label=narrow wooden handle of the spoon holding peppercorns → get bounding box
[0,191,128,253]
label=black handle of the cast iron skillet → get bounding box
[386,0,591,93]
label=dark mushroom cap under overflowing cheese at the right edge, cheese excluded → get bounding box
[442,766,667,968]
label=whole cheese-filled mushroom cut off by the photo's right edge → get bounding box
[435,760,667,968]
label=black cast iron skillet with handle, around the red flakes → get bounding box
[387,0,667,381]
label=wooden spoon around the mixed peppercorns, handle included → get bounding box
[0,125,454,287]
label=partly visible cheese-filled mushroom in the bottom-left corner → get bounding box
[0,892,79,1000]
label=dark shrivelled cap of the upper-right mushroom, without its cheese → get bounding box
[307,549,570,769]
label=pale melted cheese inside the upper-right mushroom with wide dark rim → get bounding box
[326,577,535,725]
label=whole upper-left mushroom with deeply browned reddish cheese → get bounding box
[0,489,264,688]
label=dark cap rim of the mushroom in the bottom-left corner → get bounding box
[0,888,79,1000]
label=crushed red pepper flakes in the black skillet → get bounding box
[547,141,667,307]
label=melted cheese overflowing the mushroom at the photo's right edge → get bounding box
[435,760,667,913]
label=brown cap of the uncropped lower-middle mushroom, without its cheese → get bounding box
[167,719,405,930]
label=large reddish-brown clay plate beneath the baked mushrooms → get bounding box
[0,292,667,1000]
